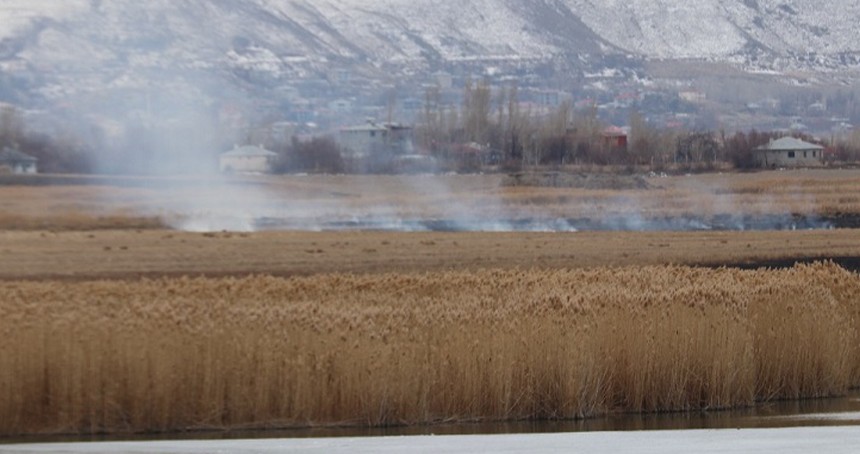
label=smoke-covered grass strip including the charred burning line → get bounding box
[0,170,860,232]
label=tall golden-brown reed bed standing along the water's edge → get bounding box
[0,263,860,435]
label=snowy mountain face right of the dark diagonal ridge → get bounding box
[566,0,860,58]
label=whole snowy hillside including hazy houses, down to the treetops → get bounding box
[0,0,860,142]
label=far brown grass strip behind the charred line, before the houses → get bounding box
[0,169,860,230]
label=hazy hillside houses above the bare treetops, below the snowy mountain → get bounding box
[228,64,860,138]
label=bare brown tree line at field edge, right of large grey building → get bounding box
[415,82,860,170]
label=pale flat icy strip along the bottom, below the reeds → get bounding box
[5,427,860,454]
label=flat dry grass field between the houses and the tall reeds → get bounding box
[0,170,860,280]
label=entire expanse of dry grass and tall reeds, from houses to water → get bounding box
[0,170,860,435]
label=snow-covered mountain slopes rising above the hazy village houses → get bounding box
[0,0,860,103]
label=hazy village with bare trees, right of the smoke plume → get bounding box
[210,58,860,172]
